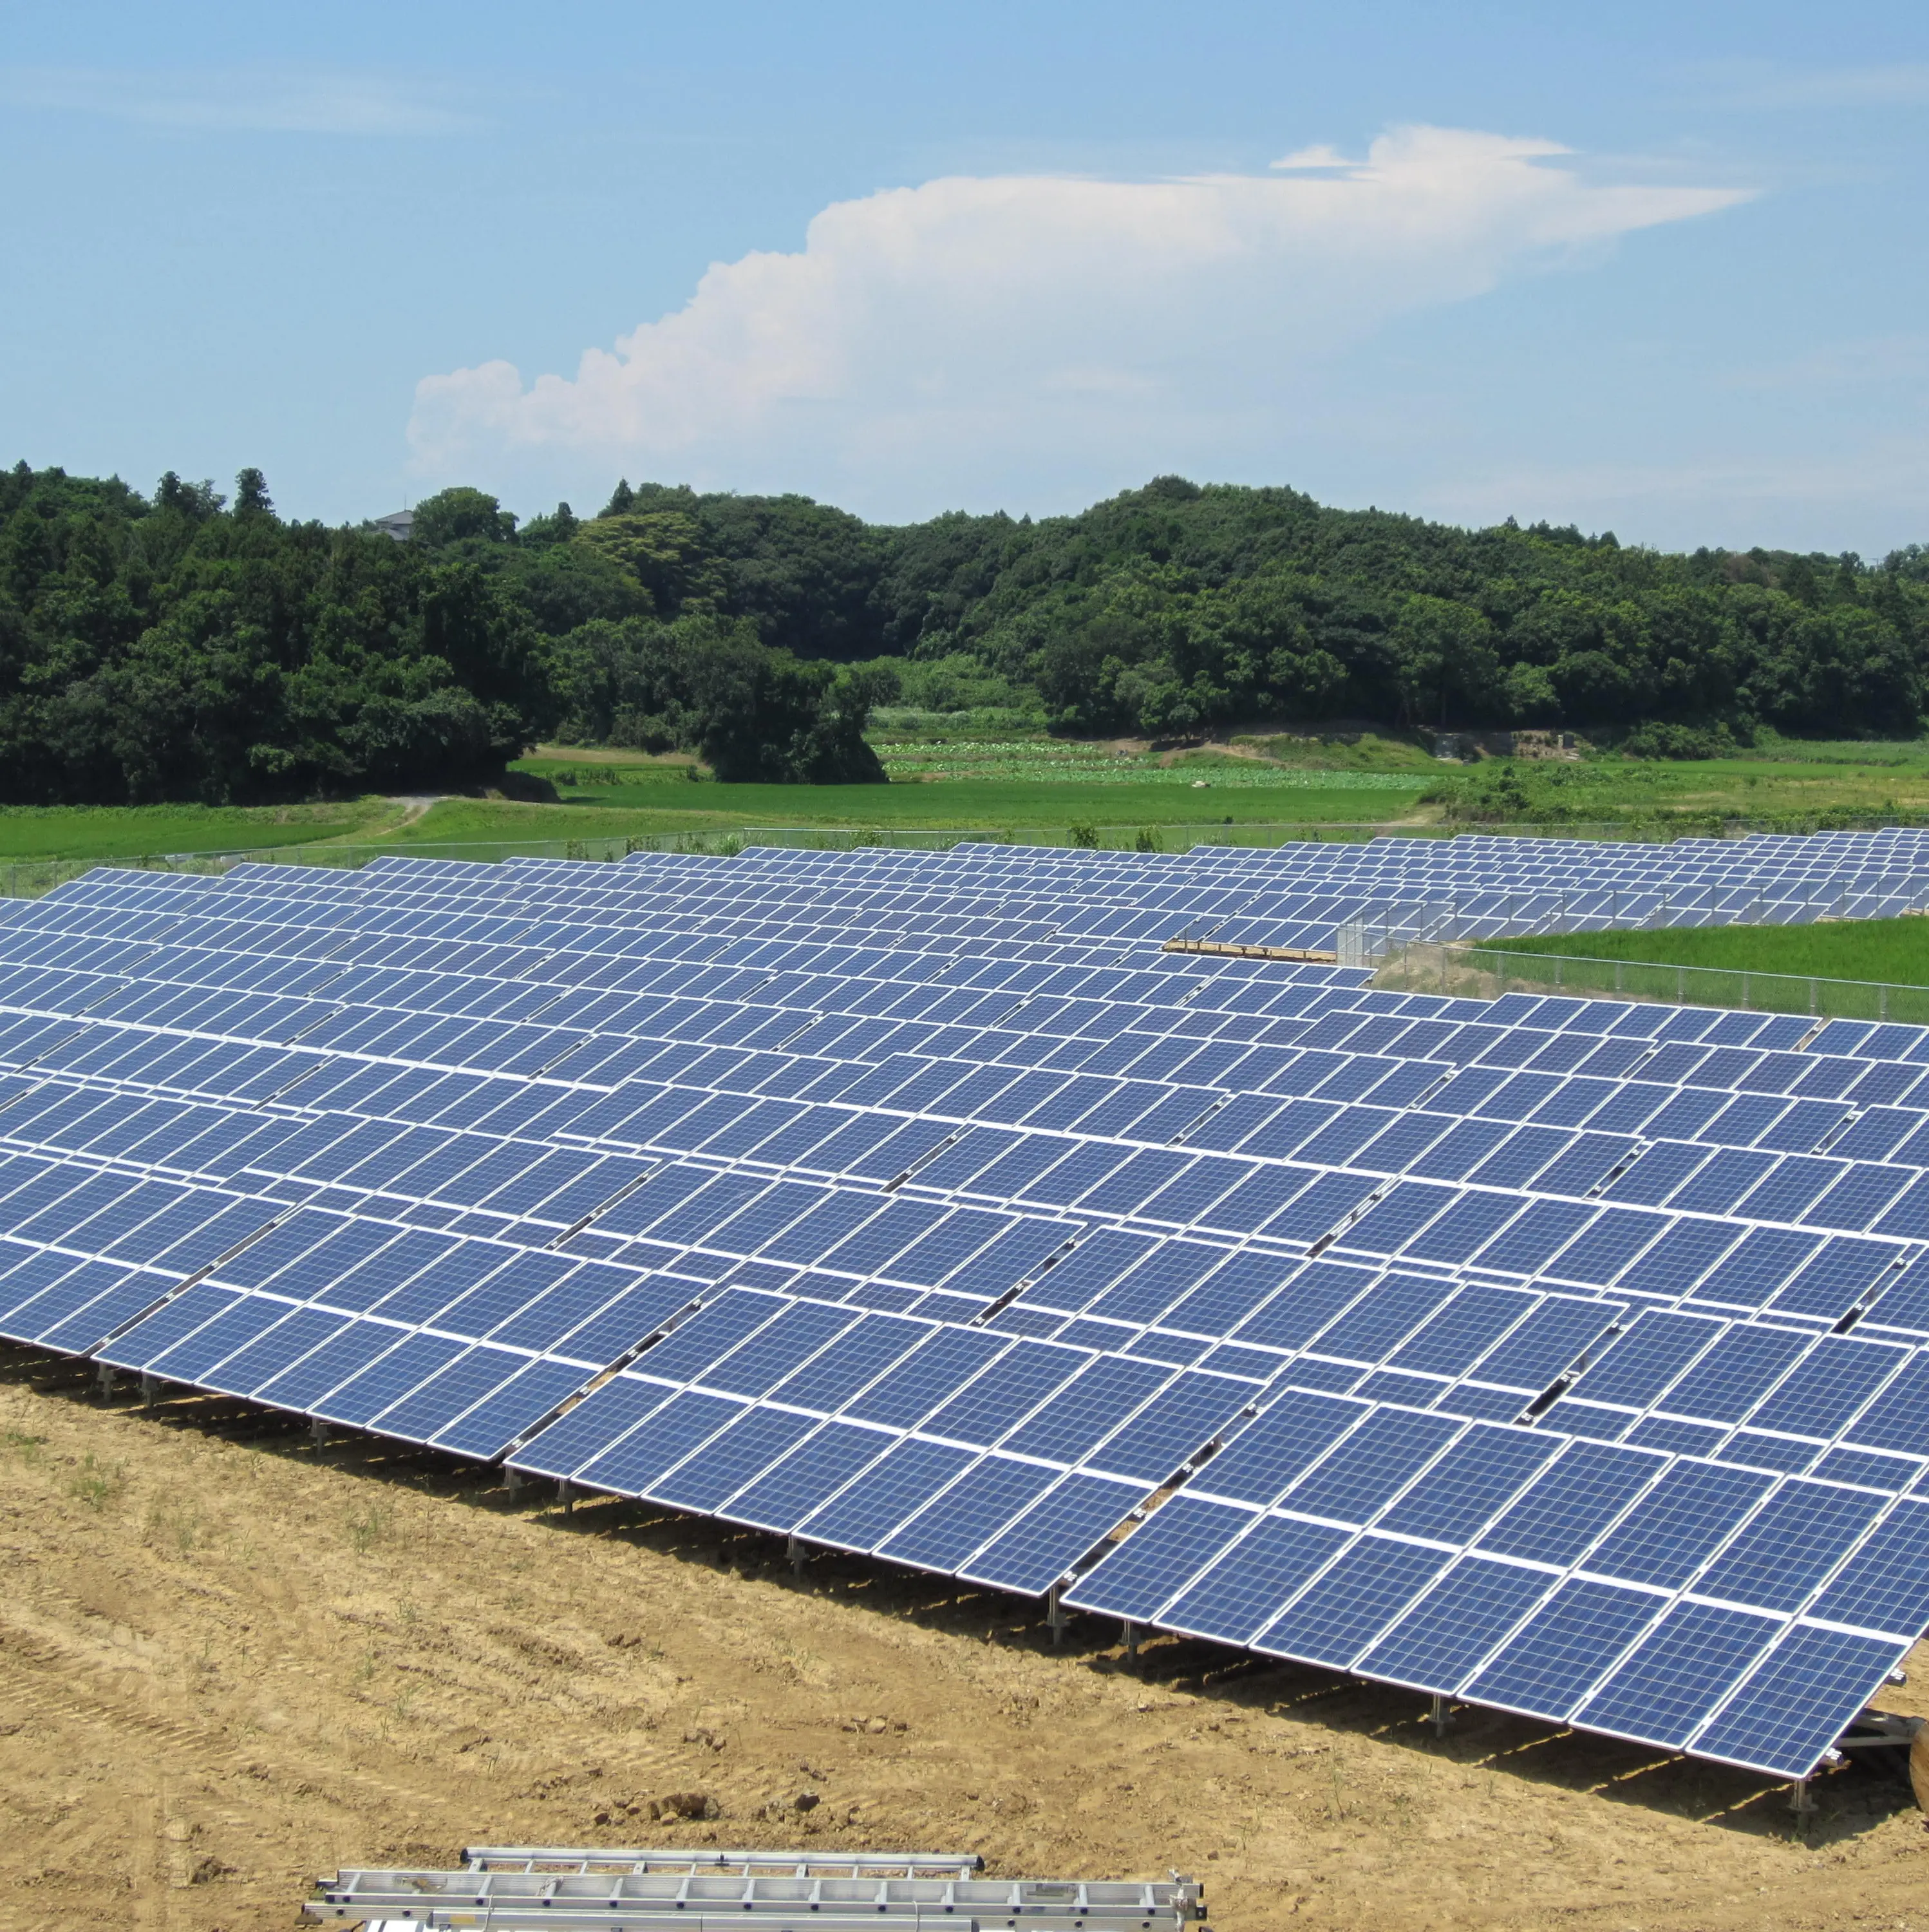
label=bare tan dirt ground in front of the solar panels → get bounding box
[0,1350,1929,1932]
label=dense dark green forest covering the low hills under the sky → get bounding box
[0,464,1929,804]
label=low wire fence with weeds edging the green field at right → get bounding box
[1373,943,1929,1026]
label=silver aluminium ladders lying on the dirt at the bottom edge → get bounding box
[303,1845,1205,1932]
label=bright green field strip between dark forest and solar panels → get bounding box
[0,726,1929,873]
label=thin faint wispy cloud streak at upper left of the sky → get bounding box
[0,68,475,135]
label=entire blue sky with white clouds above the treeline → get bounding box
[0,0,1929,558]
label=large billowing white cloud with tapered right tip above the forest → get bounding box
[409,128,1746,514]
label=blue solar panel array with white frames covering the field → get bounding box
[11,833,1929,1776]
